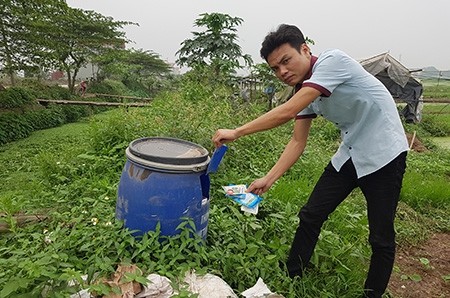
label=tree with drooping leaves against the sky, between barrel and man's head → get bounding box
[176,13,252,73]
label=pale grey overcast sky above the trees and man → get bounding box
[67,0,450,70]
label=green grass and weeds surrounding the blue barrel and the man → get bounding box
[0,86,450,298]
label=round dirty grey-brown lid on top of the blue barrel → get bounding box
[128,137,209,165]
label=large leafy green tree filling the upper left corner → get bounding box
[0,0,132,90]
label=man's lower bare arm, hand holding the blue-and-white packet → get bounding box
[247,118,312,195]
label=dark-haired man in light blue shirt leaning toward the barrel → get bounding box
[212,25,408,297]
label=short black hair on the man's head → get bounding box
[260,24,305,61]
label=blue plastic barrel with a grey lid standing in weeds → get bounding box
[116,137,210,238]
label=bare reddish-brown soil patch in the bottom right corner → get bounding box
[388,233,450,298]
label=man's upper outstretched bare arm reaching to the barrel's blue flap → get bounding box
[212,87,321,147]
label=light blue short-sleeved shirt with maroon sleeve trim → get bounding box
[296,50,408,178]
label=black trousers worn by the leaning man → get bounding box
[286,152,406,297]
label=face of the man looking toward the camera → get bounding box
[267,43,311,86]
